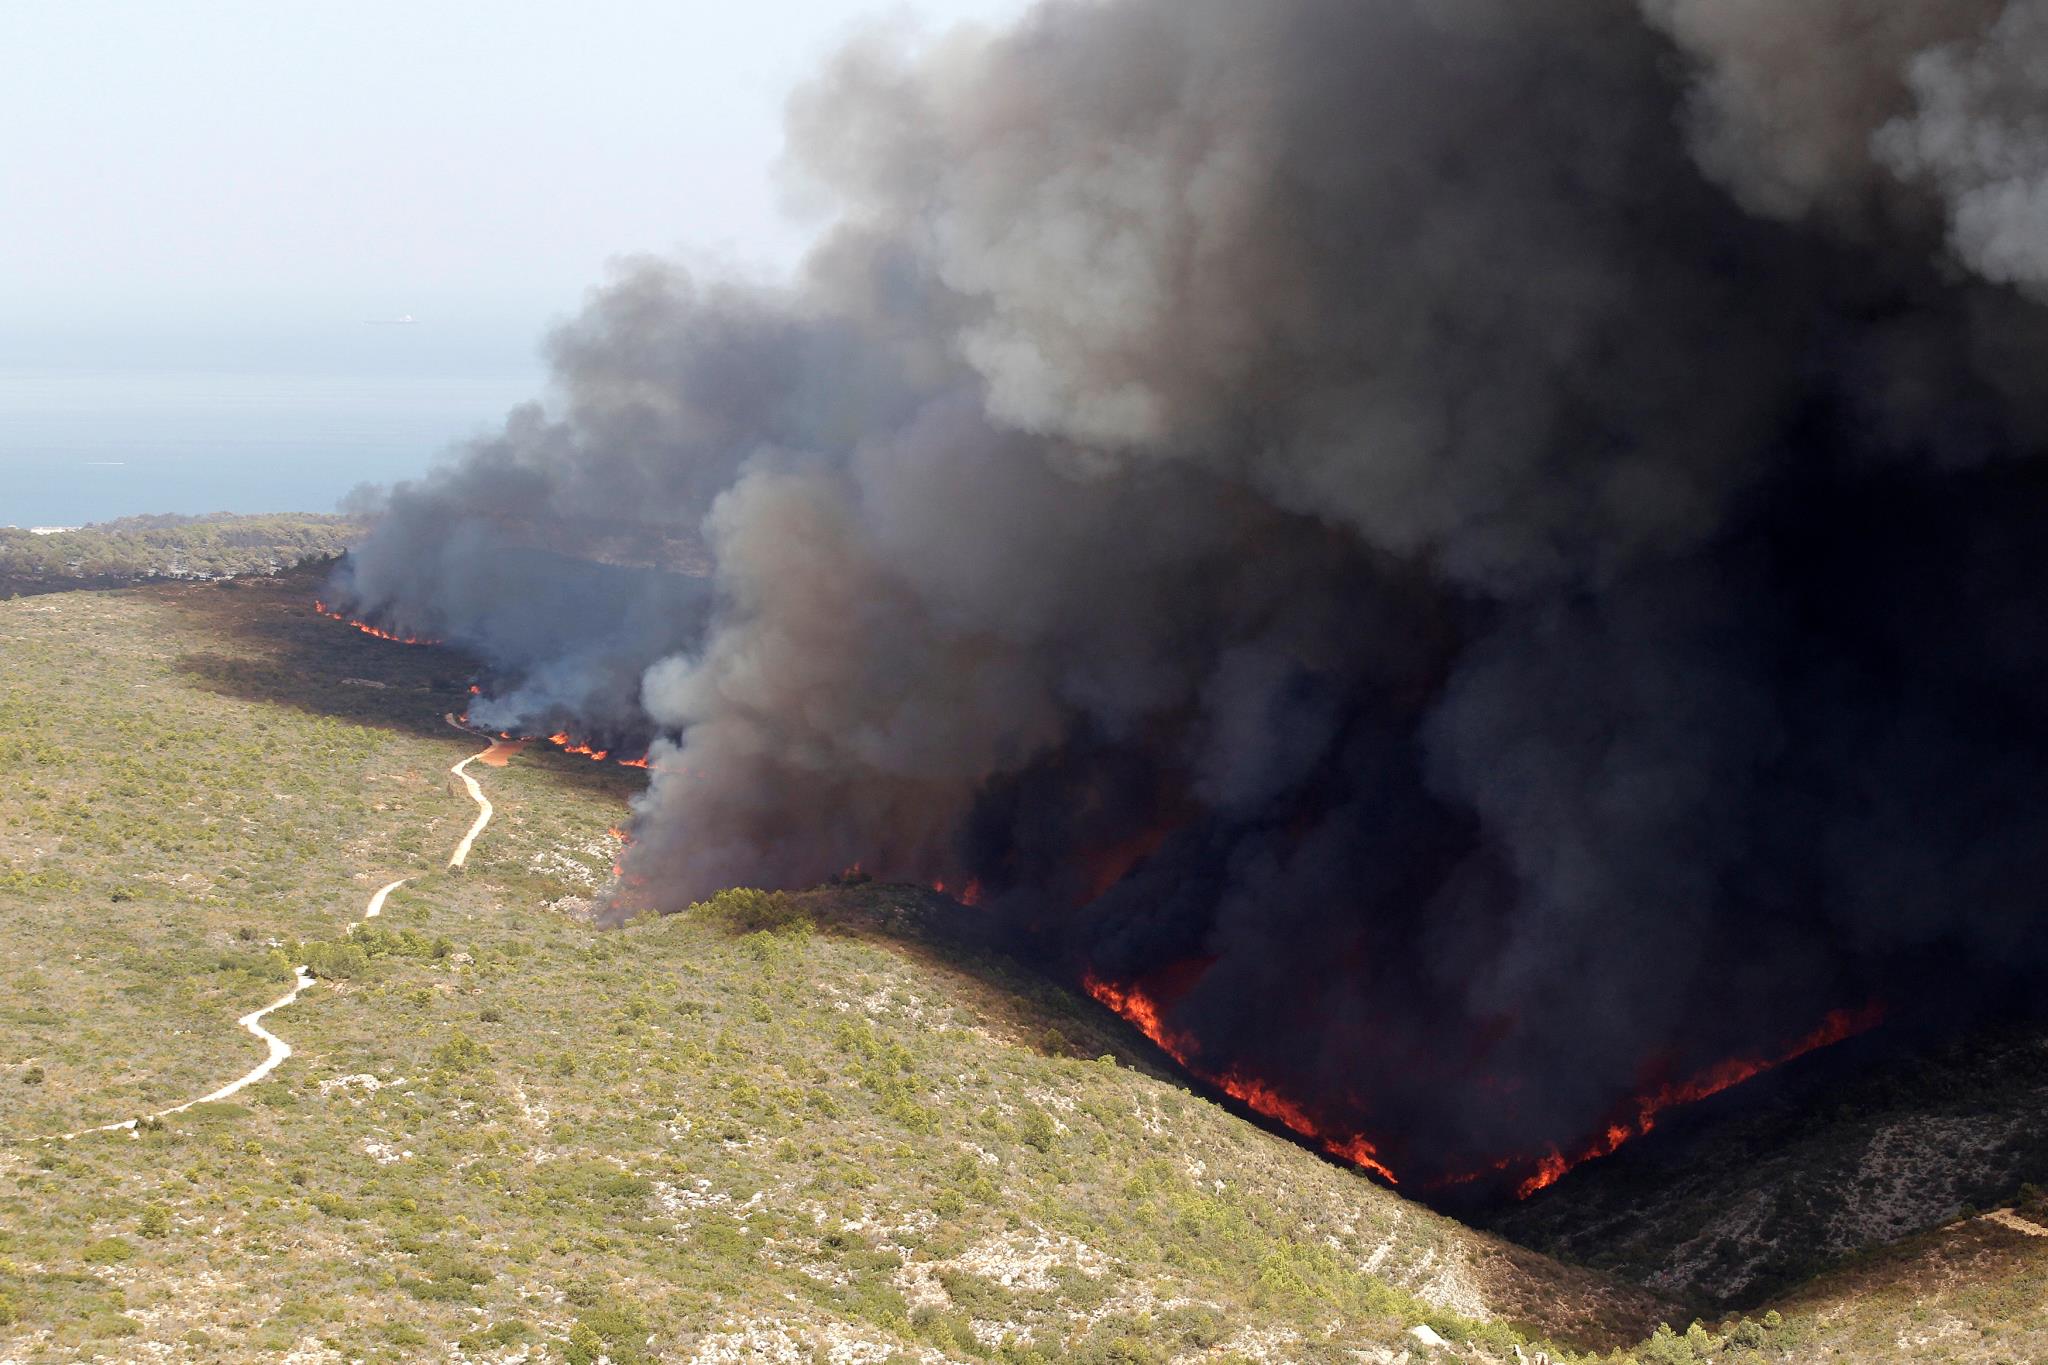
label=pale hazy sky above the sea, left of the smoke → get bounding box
[0,0,1024,364]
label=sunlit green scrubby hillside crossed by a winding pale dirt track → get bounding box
[0,579,1671,1363]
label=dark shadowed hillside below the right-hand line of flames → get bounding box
[1491,1023,2048,1308]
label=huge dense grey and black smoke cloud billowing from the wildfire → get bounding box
[327,0,2048,1175]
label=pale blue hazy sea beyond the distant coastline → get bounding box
[0,327,543,526]
